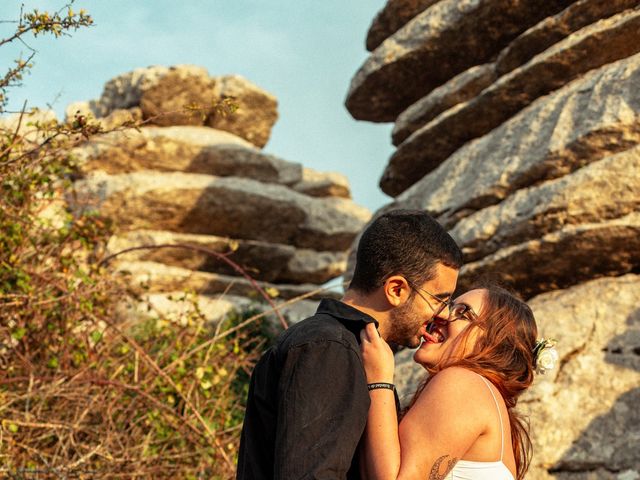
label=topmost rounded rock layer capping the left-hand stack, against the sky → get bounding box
[66,65,278,148]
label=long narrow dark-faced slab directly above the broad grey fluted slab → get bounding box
[380,10,640,195]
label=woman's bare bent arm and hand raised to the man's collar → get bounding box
[361,326,488,480]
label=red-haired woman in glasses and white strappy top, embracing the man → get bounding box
[361,286,539,480]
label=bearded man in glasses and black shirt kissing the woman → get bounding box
[237,210,462,480]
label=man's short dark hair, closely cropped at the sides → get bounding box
[349,210,462,293]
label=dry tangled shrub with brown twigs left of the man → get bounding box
[0,109,278,479]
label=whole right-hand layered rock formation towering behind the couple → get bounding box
[346,0,640,480]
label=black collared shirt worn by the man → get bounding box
[237,299,375,480]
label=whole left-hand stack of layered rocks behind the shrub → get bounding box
[67,66,370,321]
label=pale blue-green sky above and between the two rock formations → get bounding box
[0,0,393,211]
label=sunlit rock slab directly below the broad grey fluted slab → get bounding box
[449,147,640,262]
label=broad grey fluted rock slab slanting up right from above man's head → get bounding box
[389,51,640,227]
